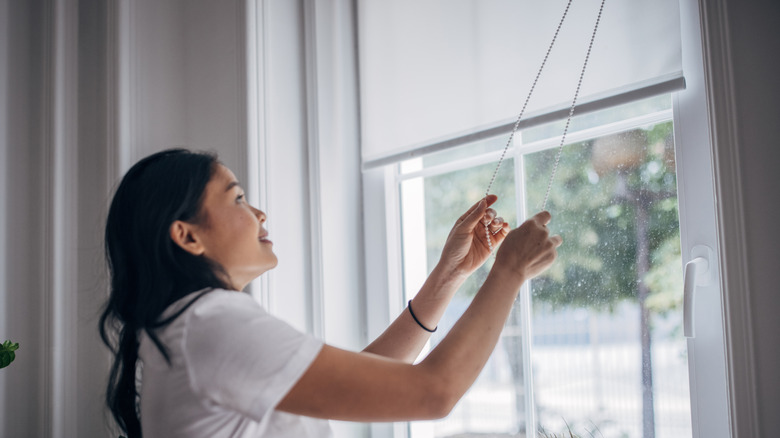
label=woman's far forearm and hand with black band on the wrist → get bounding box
[363,195,509,363]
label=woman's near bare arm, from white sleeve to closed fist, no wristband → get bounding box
[278,212,561,421]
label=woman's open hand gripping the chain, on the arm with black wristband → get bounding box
[439,195,509,276]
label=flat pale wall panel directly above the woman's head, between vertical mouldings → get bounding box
[118,0,247,181]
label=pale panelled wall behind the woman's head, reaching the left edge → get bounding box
[0,0,258,437]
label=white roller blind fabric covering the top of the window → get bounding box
[358,0,683,167]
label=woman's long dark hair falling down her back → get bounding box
[99,149,228,438]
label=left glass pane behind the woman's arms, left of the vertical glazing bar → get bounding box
[401,159,526,438]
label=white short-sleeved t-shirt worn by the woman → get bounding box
[139,290,332,438]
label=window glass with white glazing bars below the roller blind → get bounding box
[394,95,691,438]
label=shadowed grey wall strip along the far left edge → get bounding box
[0,2,46,436]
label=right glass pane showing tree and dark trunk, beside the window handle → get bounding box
[524,122,691,438]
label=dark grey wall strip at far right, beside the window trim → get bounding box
[725,0,780,437]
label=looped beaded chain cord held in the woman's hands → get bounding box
[485,0,606,252]
